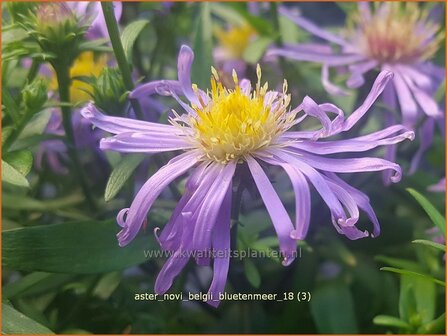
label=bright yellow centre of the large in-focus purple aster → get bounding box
[173,65,296,164]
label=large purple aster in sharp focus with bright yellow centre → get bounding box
[82,46,414,306]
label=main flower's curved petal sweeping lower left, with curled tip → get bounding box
[117,151,198,246]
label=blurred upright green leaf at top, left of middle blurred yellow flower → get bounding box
[191,2,213,89]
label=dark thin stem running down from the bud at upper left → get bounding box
[53,63,96,210]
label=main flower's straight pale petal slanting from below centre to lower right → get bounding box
[246,157,296,266]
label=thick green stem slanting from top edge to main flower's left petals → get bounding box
[101,2,144,120]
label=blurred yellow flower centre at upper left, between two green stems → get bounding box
[50,51,107,104]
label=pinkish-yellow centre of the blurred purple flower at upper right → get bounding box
[353,2,442,63]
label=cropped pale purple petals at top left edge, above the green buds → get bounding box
[67,1,123,40]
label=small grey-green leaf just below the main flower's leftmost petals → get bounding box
[104,154,145,202]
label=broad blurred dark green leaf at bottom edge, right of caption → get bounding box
[310,281,358,334]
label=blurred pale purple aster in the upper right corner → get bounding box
[268,2,445,181]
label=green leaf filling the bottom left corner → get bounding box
[2,303,54,334]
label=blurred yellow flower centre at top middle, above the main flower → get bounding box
[216,25,256,59]
